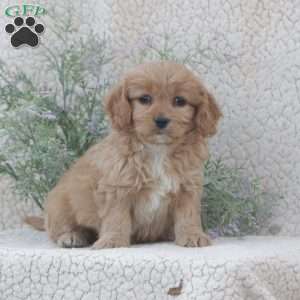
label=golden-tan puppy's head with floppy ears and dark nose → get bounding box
[105,62,221,144]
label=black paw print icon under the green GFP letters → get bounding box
[5,17,45,48]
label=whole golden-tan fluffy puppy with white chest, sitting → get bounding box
[27,62,221,249]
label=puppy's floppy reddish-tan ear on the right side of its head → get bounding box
[196,90,222,137]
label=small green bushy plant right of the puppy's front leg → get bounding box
[202,159,271,236]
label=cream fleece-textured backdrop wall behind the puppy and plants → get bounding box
[0,0,300,234]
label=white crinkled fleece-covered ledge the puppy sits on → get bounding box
[0,229,300,300]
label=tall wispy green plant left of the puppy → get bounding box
[0,14,110,208]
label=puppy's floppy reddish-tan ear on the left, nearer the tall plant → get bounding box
[104,82,131,130]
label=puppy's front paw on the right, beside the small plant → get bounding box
[175,231,212,247]
